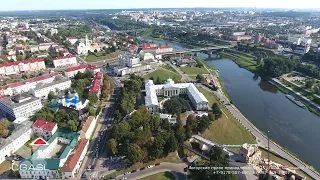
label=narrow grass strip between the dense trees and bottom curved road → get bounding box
[103,152,183,179]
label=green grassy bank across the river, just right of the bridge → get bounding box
[219,52,258,72]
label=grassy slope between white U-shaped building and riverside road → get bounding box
[198,87,256,145]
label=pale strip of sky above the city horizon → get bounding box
[0,0,320,11]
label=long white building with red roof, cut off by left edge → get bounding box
[0,58,46,76]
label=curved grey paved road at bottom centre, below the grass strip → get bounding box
[116,163,187,180]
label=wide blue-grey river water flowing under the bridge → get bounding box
[142,40,320,170]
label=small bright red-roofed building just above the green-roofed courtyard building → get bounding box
[32,119,58,140]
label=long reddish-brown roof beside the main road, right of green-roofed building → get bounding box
[62,139,88,172]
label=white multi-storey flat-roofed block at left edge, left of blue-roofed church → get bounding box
[0,93,42,119]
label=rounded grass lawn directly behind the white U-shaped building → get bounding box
[144,68,182,82]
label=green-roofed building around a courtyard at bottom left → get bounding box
[19,130,80,179]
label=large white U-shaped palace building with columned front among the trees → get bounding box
[144,79,208,113]
